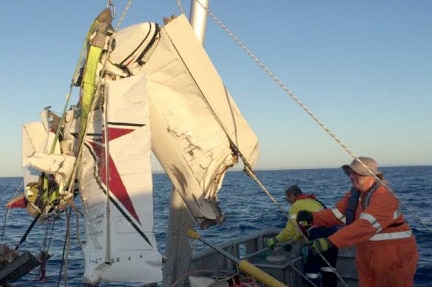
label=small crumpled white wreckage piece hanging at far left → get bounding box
[22,109,75,216]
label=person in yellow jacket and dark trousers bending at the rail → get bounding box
[266,185,338,287]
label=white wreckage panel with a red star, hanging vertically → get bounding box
[78,75,162,284]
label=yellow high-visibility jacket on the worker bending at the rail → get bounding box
[276,198,323,244]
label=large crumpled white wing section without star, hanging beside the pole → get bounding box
[111,15,258,226]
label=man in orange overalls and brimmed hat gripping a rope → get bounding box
[297,157,418,287]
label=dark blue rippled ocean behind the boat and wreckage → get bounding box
[0,166,432,287]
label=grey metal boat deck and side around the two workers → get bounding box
[189,229,357,287]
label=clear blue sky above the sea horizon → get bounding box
[0,0,432,176]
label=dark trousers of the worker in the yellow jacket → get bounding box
[303,246,338,287]
